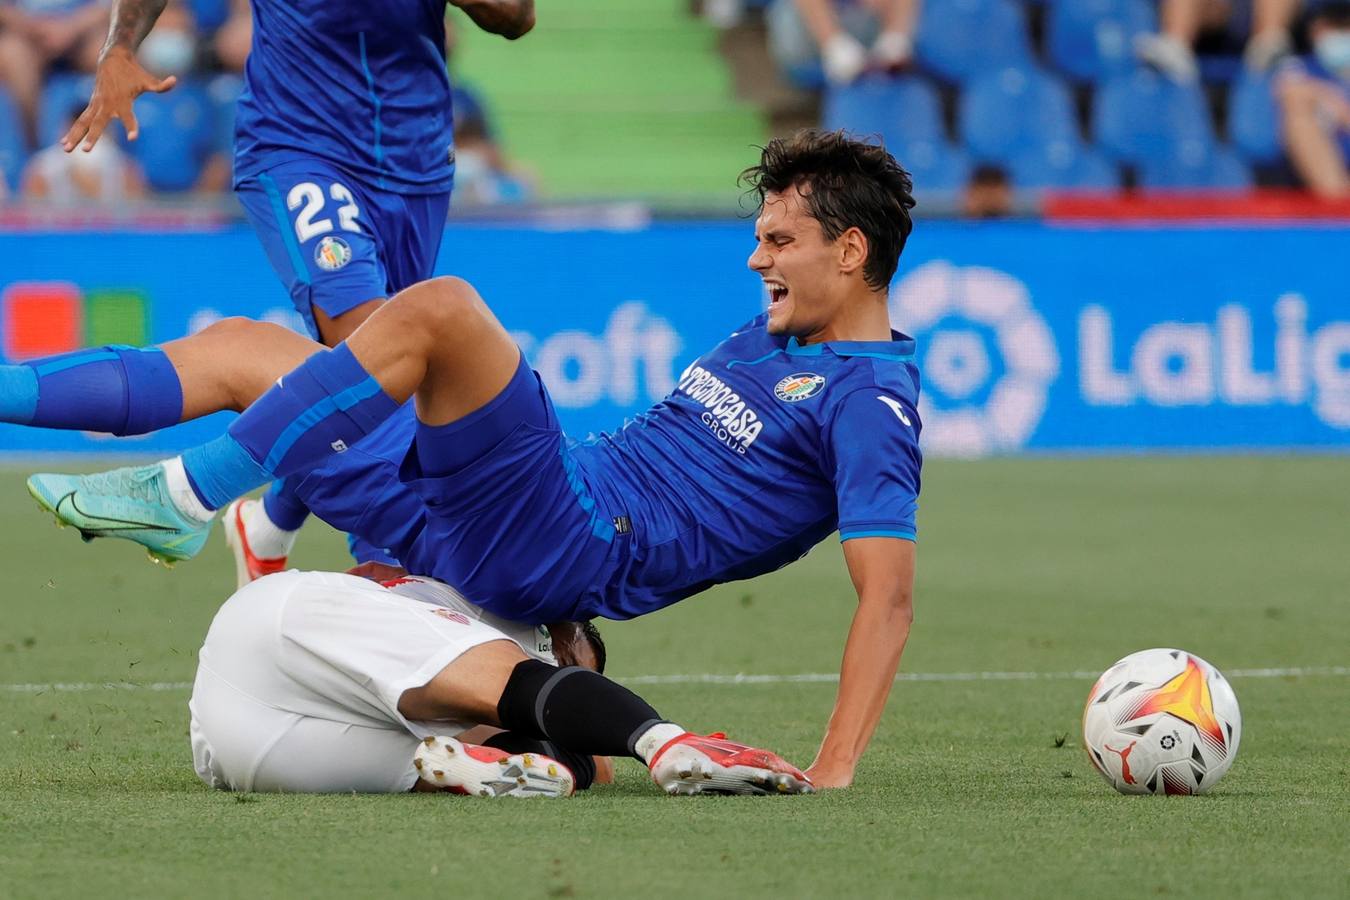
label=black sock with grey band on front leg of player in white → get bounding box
[497,660,667,760]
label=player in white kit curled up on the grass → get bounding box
[189,572,810,796]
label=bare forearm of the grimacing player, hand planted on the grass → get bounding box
[806,537,914,788]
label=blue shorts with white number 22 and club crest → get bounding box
[236,159,450,339]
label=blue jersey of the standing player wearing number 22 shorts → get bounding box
[235,0,452,193]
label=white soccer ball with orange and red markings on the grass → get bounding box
[1083,649,1242,793]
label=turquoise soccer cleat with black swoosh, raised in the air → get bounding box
[28,463,211,565]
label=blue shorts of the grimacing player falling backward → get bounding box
[391,358,621,622]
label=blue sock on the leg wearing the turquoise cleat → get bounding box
[182,344,398,509]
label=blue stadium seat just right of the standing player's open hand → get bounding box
[130,81,217,193]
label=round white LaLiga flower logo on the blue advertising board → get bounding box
[891,260,1060,456]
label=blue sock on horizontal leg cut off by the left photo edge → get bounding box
[0,347,182,434]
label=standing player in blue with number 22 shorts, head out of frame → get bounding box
[62,0,535,583]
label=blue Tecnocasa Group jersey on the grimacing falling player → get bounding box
[572,316,922,618]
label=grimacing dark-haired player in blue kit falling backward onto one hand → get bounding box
[0,132,921,787]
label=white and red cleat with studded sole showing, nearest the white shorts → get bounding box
[413,737,575,797]
